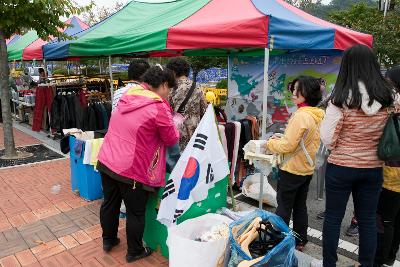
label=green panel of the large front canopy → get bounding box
[69,0,210,57]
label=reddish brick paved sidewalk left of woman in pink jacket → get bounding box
[0,126,168,267]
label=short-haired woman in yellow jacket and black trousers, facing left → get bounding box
[267,76,324,251]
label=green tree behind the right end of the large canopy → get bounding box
[330,4,400,67]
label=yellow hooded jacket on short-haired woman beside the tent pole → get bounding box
[267,107,325,176]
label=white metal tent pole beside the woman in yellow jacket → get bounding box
[258,48,269,209]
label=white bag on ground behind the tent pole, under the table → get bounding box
[242,173,278,208]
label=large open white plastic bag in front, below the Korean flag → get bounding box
[167,213,232,267]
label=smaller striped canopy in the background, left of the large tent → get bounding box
[7,17,89,61]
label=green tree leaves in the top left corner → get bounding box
[0,0,87,39]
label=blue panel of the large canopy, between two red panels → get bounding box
[252,0,335,49]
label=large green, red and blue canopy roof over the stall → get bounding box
[44,0,373,59]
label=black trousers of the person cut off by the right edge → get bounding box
[375,188,400,266]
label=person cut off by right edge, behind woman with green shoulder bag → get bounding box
[374,66,400,267]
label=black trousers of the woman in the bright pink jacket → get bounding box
[100,172,150,255]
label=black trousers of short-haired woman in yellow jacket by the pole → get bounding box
[276,170,312,245]
